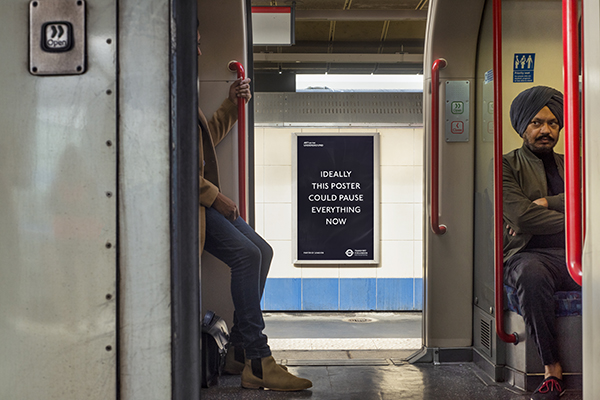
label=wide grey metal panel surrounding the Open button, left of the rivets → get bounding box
[0,0,117,400]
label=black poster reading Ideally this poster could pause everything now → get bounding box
[297,135,375,262]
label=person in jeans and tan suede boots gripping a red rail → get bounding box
[198,34,312,391]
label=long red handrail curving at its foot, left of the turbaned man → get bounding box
[493,0,519,344]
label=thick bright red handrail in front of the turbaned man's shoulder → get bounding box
[563,0,583,286]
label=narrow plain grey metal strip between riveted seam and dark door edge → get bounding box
[119,0,172,400]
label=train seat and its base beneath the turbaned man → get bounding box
[504,285,582,391]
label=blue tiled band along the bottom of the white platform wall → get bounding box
[262,278,423,311]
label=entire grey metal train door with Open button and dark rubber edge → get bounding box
[0,0,200,400]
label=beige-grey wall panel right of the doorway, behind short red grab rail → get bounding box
[423,0,483,348]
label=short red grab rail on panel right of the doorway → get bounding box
[430,58,446,235]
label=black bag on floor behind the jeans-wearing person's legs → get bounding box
[202,310,229,388]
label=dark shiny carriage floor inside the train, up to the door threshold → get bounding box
[201,351,582,400]
